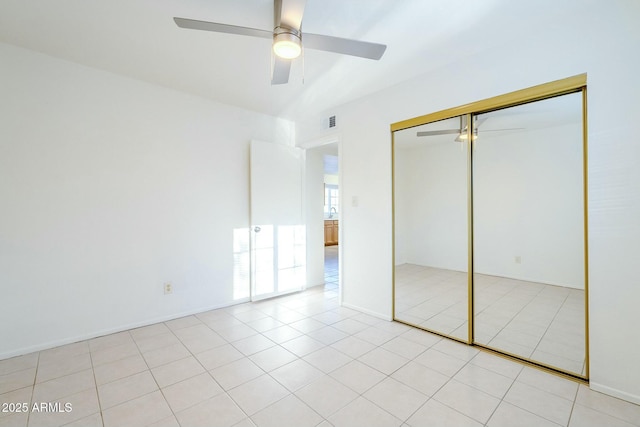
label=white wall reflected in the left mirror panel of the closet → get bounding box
[394,140,468,271]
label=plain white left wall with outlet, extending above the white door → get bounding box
[0,44,293,359]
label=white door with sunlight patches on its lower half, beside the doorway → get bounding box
[251,141,306,301]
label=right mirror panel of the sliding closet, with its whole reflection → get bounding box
[473,93,586,376]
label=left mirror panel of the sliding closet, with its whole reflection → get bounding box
[393,117,469,341]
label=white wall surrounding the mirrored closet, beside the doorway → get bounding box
[297,0,640,403]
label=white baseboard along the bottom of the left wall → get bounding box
[0,298,249,360]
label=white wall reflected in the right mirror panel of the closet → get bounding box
[473,122,584,289]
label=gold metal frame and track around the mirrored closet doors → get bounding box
[391,74,589,381]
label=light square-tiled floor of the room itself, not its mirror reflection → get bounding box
[0,251,640,427]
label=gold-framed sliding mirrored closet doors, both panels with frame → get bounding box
[392,75,589,379]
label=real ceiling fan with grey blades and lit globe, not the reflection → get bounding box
[173,0,387,85]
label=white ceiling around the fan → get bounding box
[0,0,577,119]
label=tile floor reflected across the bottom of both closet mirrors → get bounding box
[395,264,586,375]
